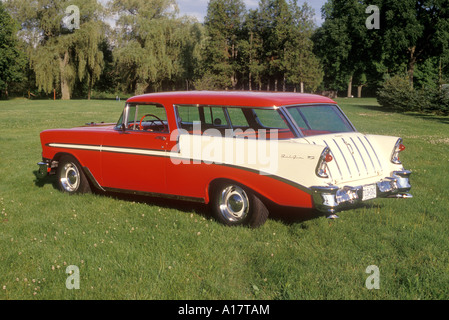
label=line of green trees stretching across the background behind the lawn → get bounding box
[0,0,449,99]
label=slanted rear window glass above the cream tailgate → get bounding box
[287,105,355,137]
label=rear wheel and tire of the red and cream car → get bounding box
[211,183,269,228]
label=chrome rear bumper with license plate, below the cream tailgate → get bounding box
[311,170,413,214]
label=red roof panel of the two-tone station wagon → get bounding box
[127,91,336,107]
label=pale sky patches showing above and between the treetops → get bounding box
[177,0,326,25]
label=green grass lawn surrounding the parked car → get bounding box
[0,99,449,300]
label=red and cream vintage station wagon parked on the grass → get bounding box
[39,92,411,227]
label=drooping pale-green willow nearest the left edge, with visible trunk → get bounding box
[6,0,103,100]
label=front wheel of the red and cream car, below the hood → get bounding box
[57,155,91,194]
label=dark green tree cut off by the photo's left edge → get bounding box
[0,2,26,97]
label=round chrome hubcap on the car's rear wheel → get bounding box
[219,186,249,222]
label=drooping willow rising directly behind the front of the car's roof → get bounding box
[110,0,196,94]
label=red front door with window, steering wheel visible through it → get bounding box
[101,105,170,194]
